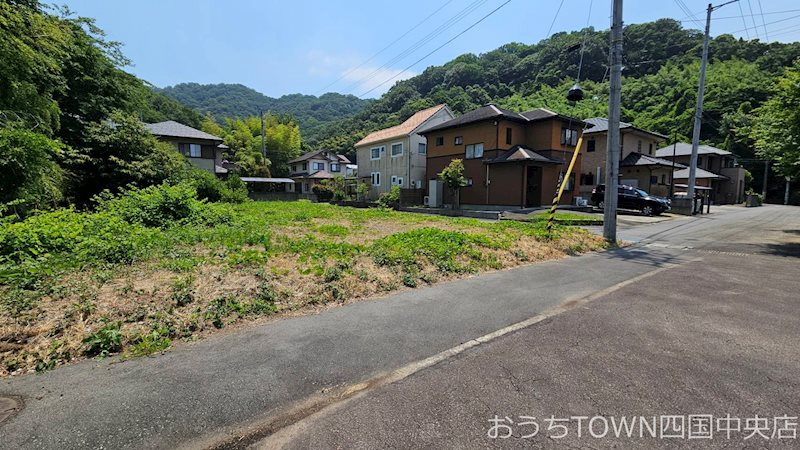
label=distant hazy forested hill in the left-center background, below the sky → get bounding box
[159,83,369,139]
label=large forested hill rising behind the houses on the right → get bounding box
[317,19,800,162]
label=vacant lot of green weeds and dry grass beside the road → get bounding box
[0,197,602,375]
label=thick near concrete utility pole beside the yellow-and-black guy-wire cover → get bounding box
[603,0,622,244]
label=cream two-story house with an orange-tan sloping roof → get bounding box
[355,105,454,199]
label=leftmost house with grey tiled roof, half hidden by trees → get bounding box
[144,120,228,176]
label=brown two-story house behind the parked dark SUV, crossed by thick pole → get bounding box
[580,117,680,197]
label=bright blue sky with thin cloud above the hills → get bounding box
[61,0,800,97]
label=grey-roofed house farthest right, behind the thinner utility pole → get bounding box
[656,142,745,204]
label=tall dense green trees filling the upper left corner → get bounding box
[0,0,209,214]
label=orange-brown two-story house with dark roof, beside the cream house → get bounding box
[421,104,586,208]
